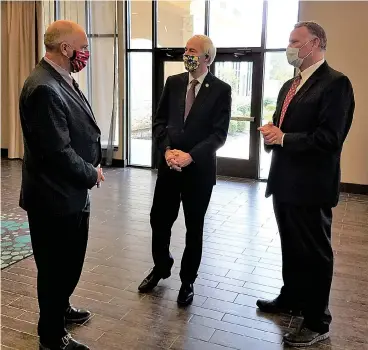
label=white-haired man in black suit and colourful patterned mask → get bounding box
[139,35,231,306]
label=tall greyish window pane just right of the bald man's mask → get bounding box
[89,38,119,147]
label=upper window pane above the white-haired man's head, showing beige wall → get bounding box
[157,0,205,47]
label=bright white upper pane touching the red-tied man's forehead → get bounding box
[266,0,299,49]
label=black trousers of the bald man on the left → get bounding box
[28,212,89,344]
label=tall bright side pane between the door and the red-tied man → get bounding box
[260,52,294,179]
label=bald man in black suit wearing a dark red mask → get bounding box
[19,21,104,350]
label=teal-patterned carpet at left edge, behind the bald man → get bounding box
[1,159,32,269]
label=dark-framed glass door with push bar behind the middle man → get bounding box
[153,49,262,178]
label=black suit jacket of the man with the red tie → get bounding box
[266,62,355,207]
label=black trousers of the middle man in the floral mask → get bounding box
[151,170,213,283]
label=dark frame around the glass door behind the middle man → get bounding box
[152,48,263,179]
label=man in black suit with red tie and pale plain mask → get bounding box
[257,22,355,346]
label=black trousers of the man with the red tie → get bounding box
[273,198,333,332]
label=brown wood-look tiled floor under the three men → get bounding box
[1,162,368,350]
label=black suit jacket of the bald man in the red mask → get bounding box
[19,60,101,215]
